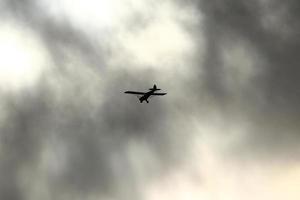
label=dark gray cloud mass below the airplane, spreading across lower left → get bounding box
[0,74,175,199]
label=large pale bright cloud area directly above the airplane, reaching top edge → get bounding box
[42,0,204,74]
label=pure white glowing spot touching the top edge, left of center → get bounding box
[41,0,131,31]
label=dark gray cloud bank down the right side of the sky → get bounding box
[198,0,300,159]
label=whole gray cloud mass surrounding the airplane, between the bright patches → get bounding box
[0,0,300,200]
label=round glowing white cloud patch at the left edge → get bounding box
[0,21,47,90]
